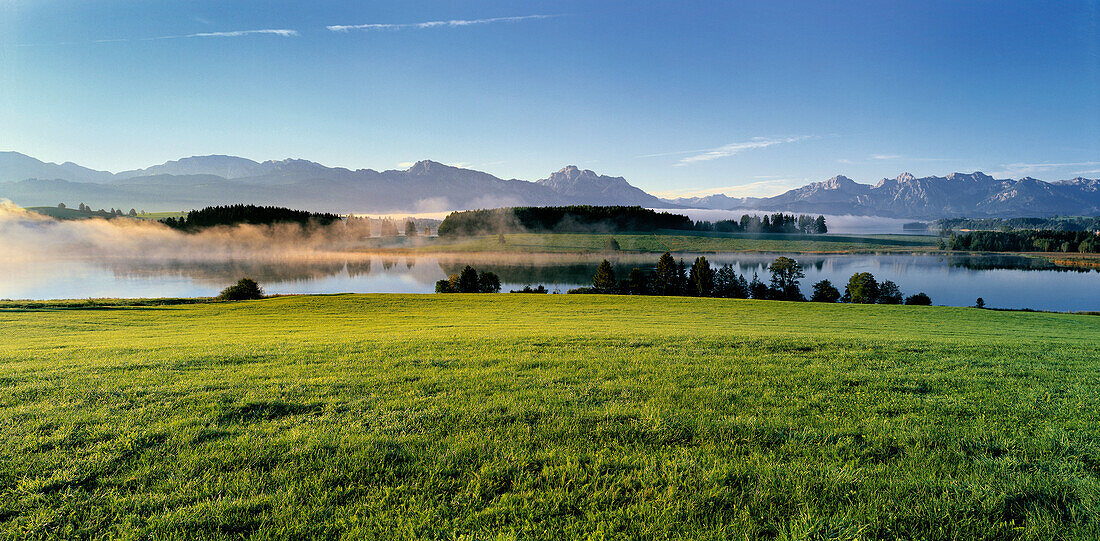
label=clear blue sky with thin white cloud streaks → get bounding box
[0,0,1100,195]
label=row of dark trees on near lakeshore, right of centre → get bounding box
[569,252,932,305]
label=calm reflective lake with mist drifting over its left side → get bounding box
[0,254,1100,311]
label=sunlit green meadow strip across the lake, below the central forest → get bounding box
[413,231,937,253]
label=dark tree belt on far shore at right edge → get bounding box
[941,230,1100,254]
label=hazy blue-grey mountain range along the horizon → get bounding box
[0,152,1100,219]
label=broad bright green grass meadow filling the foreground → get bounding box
[0,295,1100,540]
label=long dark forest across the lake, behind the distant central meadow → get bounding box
[439,205,828,236]
